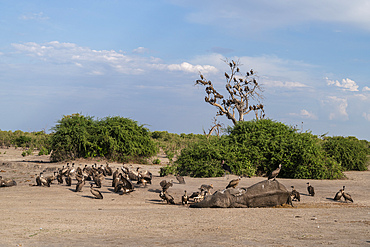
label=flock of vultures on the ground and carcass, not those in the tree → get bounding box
[0,162,353,205]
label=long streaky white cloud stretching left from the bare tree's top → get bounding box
[12,41,217,75]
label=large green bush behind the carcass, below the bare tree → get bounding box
[171,119,343,179]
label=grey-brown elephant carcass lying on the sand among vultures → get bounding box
[190,180,291,208]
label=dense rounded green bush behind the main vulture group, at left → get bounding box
[51,114,158,161]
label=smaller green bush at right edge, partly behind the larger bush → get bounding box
[323,136,369,171]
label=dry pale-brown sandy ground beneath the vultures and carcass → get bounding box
[0,149,370,246]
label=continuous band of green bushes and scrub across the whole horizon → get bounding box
[0,114,370,179]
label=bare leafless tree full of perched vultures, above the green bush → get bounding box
[195,60,265,125]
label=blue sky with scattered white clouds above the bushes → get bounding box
[0,0,370,141]
